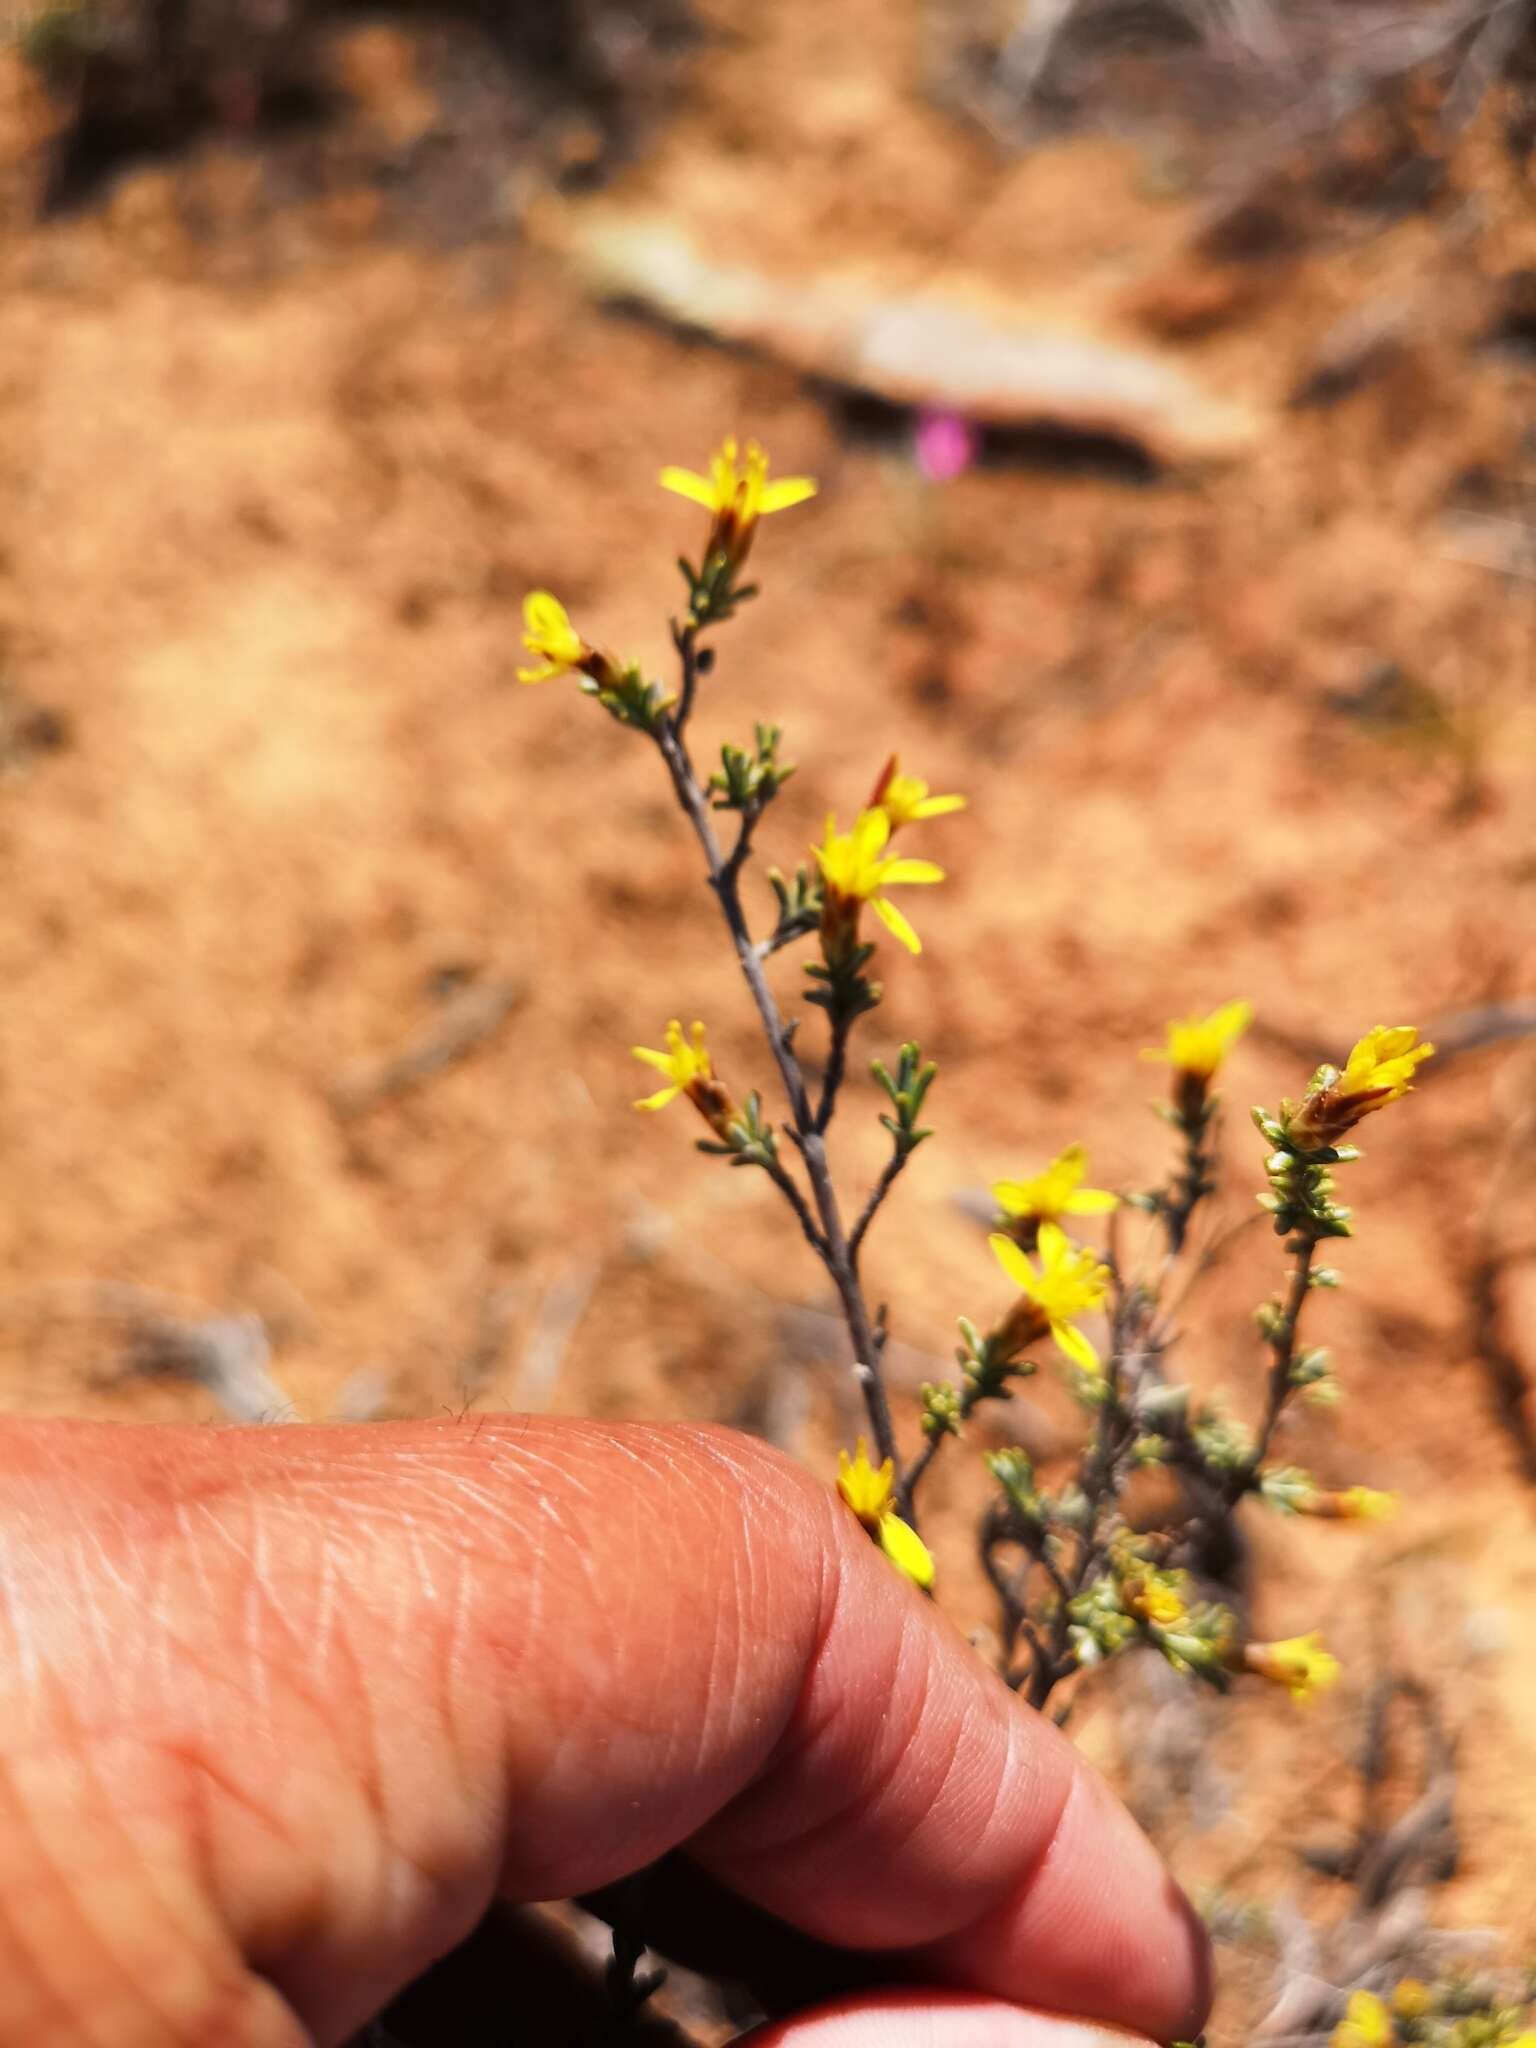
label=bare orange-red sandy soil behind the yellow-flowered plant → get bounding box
[0,0,1536,2040]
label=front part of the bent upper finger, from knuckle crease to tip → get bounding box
[694,1474,1210,2040]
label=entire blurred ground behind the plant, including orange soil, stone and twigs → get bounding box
[0,0,1536,2042]
